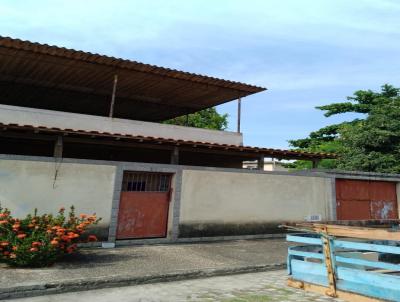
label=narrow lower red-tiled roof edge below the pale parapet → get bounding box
[0,123,336,160]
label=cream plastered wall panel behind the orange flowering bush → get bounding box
[0,160,116,225]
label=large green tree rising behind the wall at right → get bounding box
[289,85,400,173]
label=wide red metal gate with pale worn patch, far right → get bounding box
[336,179,398,220]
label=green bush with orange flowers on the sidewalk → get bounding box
[0,206,100,267]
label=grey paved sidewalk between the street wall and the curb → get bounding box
[0,239,287,297]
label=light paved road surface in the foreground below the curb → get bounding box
[7,270,340,302]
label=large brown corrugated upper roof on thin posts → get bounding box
[0,36,265,121]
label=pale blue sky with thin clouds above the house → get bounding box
[0,0,400,148]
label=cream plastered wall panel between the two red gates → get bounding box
[180,170,332,224]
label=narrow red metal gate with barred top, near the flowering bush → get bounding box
[117,172,171,239]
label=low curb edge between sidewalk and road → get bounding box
[0,263,286,300]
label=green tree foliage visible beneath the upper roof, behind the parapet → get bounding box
[164,108,228,130]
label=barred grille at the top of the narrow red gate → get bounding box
[122,172,171,192]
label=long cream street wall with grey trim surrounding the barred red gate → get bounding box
[0,154,400,244]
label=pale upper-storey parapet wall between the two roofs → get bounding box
[0,105,243,145]
